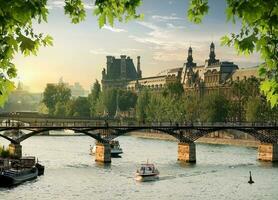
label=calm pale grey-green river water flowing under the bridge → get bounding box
[0,136,278,200]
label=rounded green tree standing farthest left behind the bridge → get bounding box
[42,83,71,115]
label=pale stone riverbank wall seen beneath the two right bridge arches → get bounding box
[129,132,260,147]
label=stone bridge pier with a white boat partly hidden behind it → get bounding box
[95,142,111,163]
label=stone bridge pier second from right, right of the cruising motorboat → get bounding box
[178,142,196,163]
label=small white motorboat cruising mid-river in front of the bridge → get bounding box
[135,162,159,182]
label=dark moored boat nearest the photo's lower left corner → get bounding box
[0,167,38,187]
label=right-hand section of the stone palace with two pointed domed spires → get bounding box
[181,43,258,96]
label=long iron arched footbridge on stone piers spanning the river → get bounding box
[0,117,278,162]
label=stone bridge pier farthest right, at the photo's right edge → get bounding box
[258,143,278,162]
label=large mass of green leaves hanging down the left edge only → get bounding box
[0,0,52,105]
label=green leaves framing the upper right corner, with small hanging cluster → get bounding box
[188,0,278,107]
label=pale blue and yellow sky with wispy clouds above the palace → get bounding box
[15,0,261,92]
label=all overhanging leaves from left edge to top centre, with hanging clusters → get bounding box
[0,0,141,105]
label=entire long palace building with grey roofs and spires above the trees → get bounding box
[101,43,258,95]
